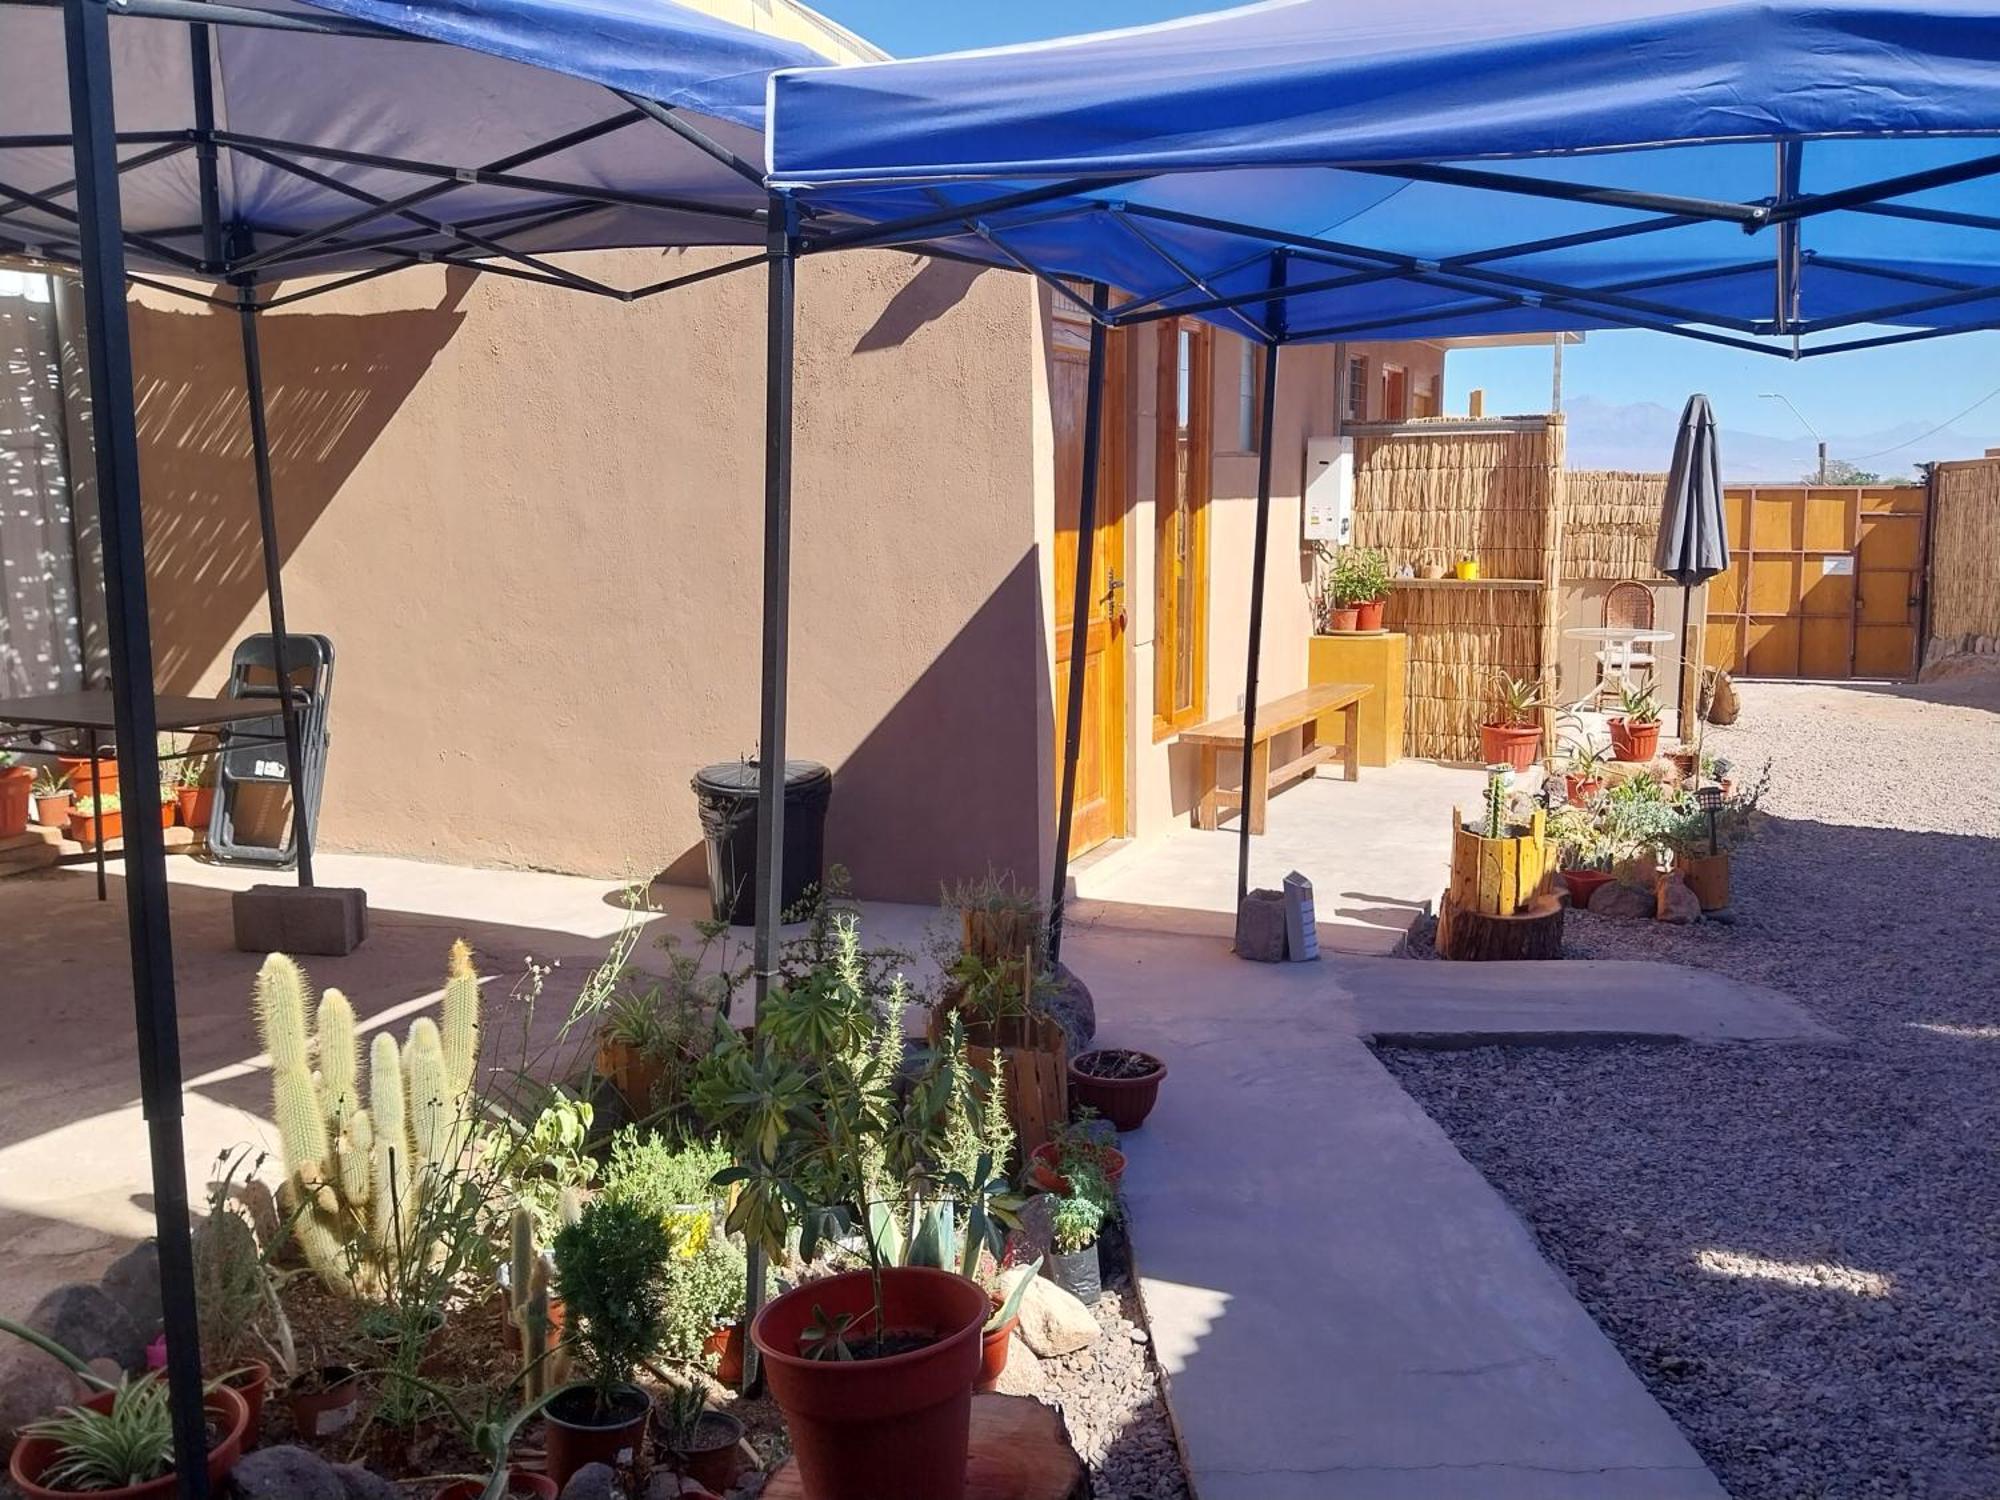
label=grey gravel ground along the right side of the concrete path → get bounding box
[1384,674,2000,1500]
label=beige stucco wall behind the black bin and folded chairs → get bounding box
[134,252,1052,900]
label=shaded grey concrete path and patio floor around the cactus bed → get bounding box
[0,852,1828,1500]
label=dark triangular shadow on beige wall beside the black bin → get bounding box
[658,550,1054,904]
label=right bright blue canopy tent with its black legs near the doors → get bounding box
[766,0,2000,942]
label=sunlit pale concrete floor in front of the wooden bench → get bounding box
[1072,760,1484,954]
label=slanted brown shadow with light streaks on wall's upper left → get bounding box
[130,270,472,692]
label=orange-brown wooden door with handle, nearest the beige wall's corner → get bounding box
[1048,310,1130,856]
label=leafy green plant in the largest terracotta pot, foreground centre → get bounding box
[696,918,1004,1500]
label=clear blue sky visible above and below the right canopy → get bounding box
[818,0,2000,472]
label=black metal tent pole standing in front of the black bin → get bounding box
[742,192,798,1392]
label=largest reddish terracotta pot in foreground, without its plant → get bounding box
[750,1266,992,1500]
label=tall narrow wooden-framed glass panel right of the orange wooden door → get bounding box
[1152,318,1216,740]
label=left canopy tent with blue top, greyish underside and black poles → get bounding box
[0,0,816,1496]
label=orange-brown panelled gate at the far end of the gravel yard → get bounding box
[1706,484,1926,678]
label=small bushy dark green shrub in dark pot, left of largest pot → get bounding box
[542,1198,674,1488]
